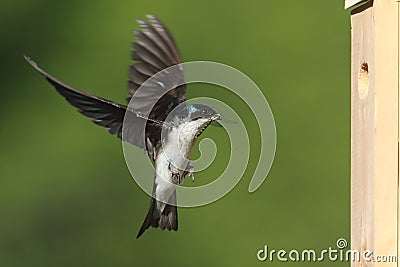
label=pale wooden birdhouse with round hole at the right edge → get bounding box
[345,0,400,266]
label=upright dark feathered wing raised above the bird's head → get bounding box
[128,15,186,121]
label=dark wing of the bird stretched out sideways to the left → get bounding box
[25,56,157,148]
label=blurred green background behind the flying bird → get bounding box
[0,0,350,267]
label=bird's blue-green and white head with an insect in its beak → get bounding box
[187,104,221,138]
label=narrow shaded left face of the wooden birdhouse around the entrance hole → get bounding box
[351,4,375,266]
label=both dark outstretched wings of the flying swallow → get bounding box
[25,15,186,157]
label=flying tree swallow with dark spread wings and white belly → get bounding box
[25,15,221,238]
